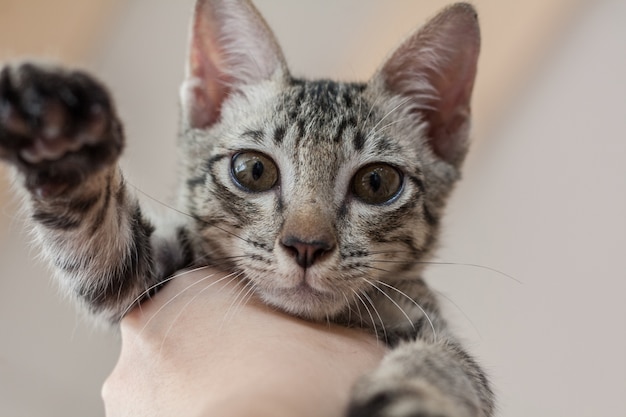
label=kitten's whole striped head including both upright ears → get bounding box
[176,0,480,319]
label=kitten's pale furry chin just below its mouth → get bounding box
[259,283,345,321]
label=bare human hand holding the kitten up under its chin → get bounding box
[102,269,385,417]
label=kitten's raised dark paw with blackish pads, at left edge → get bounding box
[0,63,124,196]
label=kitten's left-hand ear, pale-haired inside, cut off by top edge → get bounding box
[181,0,287,129]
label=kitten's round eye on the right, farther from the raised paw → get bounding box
[352,163,402,204]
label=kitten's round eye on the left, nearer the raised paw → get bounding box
[231,151,278,193]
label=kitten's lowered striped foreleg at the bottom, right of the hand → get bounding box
[347,324,494,417]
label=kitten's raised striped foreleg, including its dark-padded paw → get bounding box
[0,64,186,321]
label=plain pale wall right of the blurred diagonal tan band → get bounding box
[442,0,626,417]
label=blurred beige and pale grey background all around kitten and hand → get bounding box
[0,0,626,417]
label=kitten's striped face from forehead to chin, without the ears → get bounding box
[183,80,446,319]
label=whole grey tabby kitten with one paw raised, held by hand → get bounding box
[0,0,494,417]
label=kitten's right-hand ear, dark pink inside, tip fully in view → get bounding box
[371,3,480,166]
